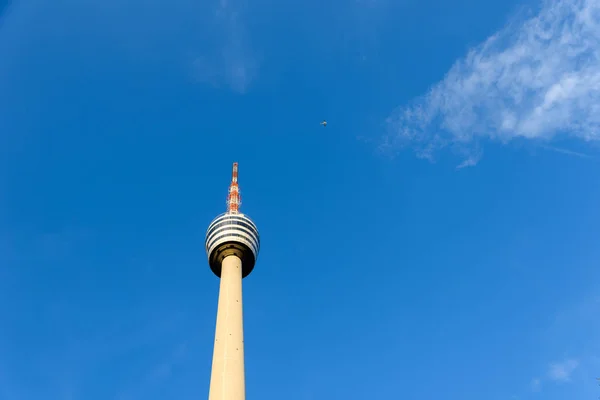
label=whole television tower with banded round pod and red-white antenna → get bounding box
[205,163,260,400]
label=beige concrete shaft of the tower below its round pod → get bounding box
[208,255,246,400]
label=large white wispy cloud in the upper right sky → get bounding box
[382,0,600,166]
